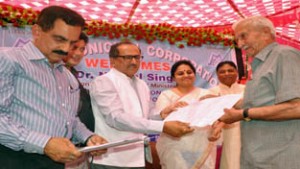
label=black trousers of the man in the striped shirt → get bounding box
[0,144,65,169]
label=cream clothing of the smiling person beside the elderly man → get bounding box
[209,83,245,169]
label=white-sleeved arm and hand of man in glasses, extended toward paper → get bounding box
[90,76,193,137]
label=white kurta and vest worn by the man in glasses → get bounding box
[90,68,163,167]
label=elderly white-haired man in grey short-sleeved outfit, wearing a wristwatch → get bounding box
[219,16,300,169]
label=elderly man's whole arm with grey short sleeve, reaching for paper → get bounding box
[220,48,300,123]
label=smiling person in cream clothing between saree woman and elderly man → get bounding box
[209,61,245,169]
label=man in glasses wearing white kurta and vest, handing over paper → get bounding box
[90,42,193,169]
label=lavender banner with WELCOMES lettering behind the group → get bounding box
[0,27,236,101]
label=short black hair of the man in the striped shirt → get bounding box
[36,6,85,32]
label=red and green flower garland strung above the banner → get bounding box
[0,4,234,48]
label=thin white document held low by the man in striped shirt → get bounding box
[78,137,144,152]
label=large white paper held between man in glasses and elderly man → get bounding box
[164,94,242,127]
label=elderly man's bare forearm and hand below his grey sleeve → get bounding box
[220,99,300,123]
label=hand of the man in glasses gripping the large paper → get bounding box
[163,121,194,137]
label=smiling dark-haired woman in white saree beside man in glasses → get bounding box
[156,60,216,169]
